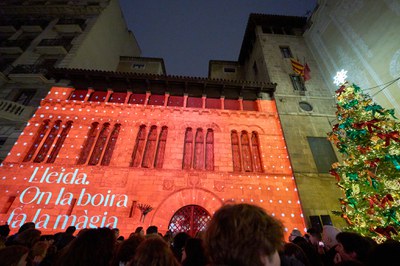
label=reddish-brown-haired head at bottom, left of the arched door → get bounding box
[130,236,179,266]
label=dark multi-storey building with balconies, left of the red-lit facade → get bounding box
[0,0,140,161]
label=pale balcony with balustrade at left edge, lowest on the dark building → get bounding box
[0,99,35,121]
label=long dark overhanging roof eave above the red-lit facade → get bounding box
[49,68,276,99]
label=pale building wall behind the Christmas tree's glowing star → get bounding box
[304,0,400,113]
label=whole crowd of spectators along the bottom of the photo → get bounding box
[0,204,400,266]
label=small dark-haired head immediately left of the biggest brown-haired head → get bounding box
[182,238,208,266]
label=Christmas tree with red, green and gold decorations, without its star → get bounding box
[328,78,400,242]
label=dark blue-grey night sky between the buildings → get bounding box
[120,0,317,77]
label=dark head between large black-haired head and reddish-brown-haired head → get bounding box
[112,234,145,266]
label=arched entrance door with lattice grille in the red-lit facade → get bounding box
[168,205,211,237]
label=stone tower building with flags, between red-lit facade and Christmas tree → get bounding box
[209,14,343,227]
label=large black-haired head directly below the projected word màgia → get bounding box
[56,228,116,266]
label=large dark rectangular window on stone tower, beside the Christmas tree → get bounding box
[307,137,338,173]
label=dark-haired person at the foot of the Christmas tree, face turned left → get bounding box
[334,232,374,264]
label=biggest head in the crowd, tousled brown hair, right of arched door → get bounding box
[205,204,283,266]
